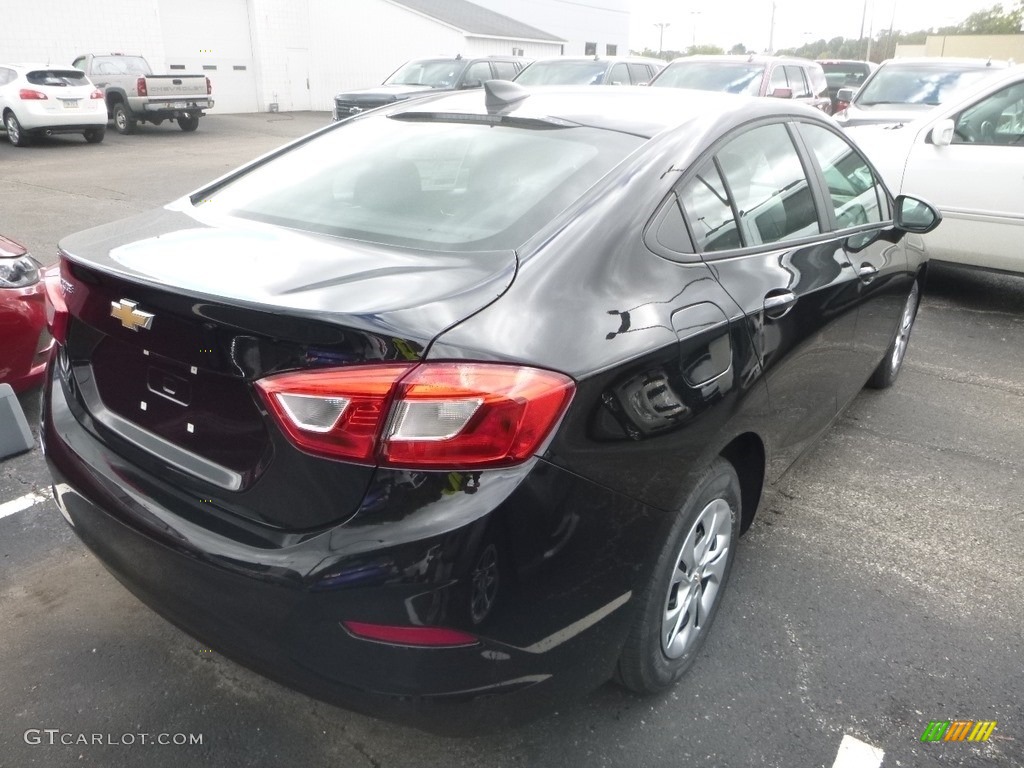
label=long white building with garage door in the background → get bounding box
[0,0,577,112]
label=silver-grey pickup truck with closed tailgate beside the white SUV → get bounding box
[74,53,213,133]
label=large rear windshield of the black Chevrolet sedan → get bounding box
[199,116,644,251]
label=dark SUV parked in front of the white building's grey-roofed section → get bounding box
[334,55,530,120]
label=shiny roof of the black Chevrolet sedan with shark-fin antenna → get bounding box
[385,84,822,138]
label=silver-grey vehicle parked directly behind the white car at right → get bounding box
[836,57,1009,128]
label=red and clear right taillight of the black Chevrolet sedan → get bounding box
[256,362,575,469]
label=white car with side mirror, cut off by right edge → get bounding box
[847,67,1024,273]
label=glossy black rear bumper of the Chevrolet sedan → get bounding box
[42,364,652,733]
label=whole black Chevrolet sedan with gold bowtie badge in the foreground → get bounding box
[42,82,937,730]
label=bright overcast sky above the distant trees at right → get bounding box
[630,0,1012,51]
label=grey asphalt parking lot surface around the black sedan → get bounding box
[0,113,1024,768]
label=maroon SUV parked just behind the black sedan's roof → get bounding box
[650,55,831,115]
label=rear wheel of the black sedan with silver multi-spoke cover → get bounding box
[615,457,740,693]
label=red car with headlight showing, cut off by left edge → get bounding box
[0,236,53,392]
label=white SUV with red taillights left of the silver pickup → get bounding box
[0,65,106,146]
